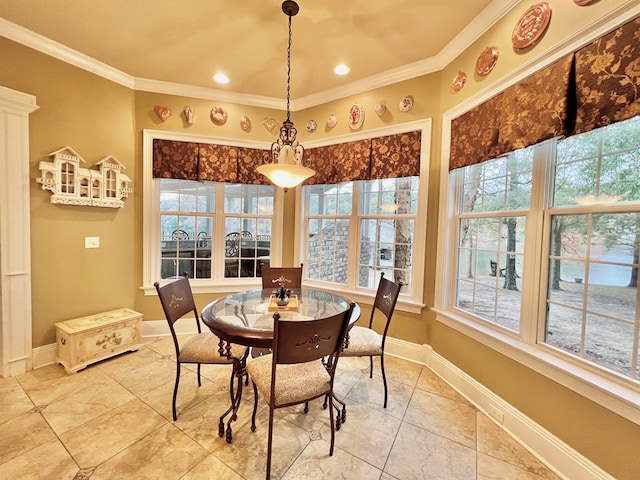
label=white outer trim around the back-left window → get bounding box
[140,129,284,295]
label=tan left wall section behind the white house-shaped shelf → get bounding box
[0,38,136,347]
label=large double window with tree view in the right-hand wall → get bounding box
[436,117,640,410]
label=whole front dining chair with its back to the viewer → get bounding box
[247,303,355,480]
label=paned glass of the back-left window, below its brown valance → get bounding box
[154,179,274,279]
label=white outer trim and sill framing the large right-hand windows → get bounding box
[432,2,640,425]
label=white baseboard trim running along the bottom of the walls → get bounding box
[33,328,615,480]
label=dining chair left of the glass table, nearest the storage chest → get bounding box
[153,274,247,421]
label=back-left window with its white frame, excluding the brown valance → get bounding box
[143,130,282,295]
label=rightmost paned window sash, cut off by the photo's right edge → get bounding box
[543,117,640,380]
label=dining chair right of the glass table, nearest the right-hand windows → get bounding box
[342,272,402,408]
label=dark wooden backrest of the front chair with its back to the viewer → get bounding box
[273,303,355,370]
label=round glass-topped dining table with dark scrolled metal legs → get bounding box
[202,287,360,443]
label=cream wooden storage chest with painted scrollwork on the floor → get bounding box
[56,308,142,373]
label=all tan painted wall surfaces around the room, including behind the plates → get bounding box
[0,0,640,479]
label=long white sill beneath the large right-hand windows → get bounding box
[433,309,640,425]
